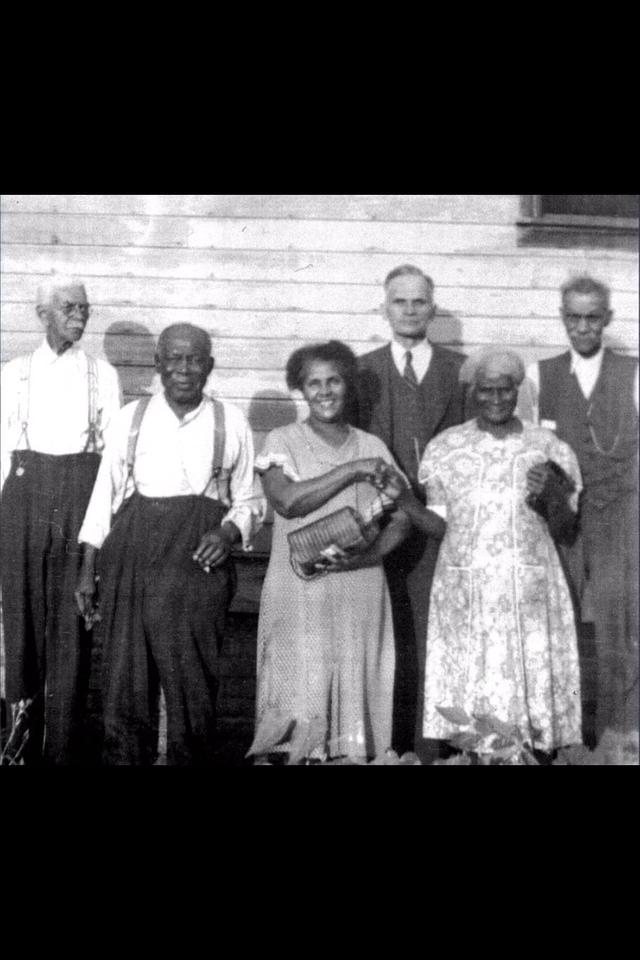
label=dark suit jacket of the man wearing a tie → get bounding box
[354,344,469,452]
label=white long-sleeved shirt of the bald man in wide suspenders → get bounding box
[78,392,265,550]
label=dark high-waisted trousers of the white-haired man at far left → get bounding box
[0,451,100,764]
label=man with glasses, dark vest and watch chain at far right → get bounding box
[520,275,638,740]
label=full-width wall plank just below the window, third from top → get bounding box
[2,244,638,288]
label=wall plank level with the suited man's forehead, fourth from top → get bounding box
[2,273,638,319]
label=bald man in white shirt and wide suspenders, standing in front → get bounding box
[76,324,263,766]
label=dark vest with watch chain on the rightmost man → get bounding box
[539,349,638,510]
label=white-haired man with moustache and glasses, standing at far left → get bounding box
[0,277,120,765]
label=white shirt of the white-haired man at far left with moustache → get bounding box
[0,340,121,485]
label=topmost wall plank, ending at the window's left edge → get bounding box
[0,194,520,223]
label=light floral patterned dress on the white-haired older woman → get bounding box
[418,420,582,750]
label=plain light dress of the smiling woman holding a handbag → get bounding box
[256,423,395,758]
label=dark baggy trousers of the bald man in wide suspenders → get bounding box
[98,493,235,766]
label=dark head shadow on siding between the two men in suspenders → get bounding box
[102,321,156,403]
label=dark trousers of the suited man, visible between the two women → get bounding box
[385,530,439,762]
